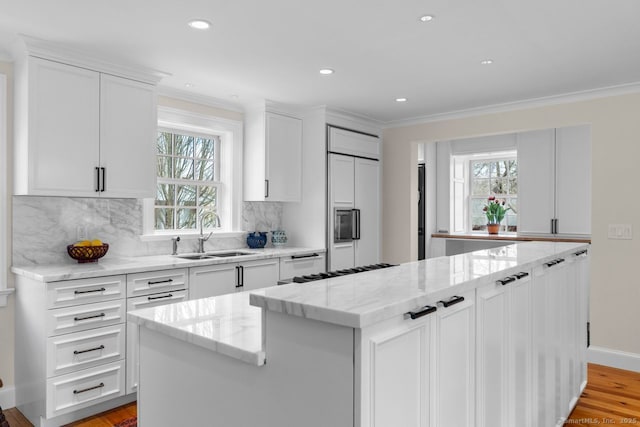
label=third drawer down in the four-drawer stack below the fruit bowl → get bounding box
[47,323,125,377]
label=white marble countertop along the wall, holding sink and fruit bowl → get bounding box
[11,247,326,282]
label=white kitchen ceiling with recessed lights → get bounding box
[0,0,640,123]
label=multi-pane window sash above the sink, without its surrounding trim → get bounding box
[154,128,224,230]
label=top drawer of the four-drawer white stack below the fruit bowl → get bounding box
[47,275,126,308]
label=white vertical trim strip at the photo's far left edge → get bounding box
[0,74,14,307]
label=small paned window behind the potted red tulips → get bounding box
[469,155,518,232]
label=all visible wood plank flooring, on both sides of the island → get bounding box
[4,364,640,427]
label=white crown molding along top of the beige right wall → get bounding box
[383,82,640,129]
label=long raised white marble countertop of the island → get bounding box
[250,242,588,328]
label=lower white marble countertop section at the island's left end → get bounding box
[127,292,265,366]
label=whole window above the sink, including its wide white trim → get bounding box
[143,106,242,236]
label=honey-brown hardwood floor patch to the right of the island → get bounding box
[565,364,640,427]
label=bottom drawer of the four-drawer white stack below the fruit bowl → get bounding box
[47,360,125,418]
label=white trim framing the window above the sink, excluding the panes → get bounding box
[141,106,243,241]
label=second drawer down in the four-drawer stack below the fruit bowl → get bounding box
[47,300,125,337]
